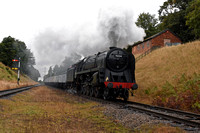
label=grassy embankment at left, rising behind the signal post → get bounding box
[0,62,36,90]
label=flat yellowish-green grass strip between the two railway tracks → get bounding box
[0,87,131,133]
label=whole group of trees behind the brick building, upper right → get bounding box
[136,0,200,42]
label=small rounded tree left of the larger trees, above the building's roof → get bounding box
[135,13,158,38]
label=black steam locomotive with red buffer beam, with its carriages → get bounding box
[44,47,138,101]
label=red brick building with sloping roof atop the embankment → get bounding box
[132,29,181,54]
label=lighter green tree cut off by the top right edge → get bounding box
[186,0,200,39]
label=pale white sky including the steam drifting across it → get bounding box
[0,0,166,79]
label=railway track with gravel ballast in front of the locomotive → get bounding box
[78,95,200,132]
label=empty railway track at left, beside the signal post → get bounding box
[0,84,41,98]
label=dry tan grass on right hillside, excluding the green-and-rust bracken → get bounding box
[133,41,200,111]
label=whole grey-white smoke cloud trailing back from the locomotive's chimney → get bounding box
[34,7,145,78]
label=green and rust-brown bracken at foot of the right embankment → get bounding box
[154,73,200,112]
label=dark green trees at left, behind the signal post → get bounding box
[0,36,40,80]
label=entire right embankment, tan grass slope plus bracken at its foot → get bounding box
[133,41,200,113]
